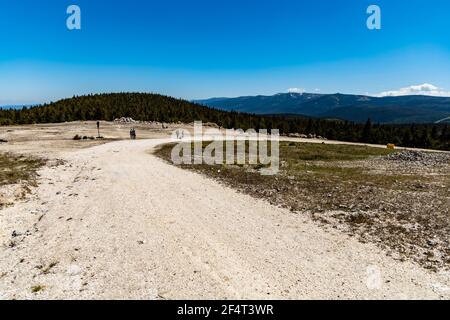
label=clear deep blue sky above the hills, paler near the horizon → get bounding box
[0,0,450,104]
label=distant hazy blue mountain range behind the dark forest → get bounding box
[195,93,450,124]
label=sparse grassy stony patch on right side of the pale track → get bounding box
[157,142,450,270]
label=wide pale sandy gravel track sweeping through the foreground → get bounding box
[0,125,450,299]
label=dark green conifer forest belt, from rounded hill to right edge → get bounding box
[0,93,450,150]
